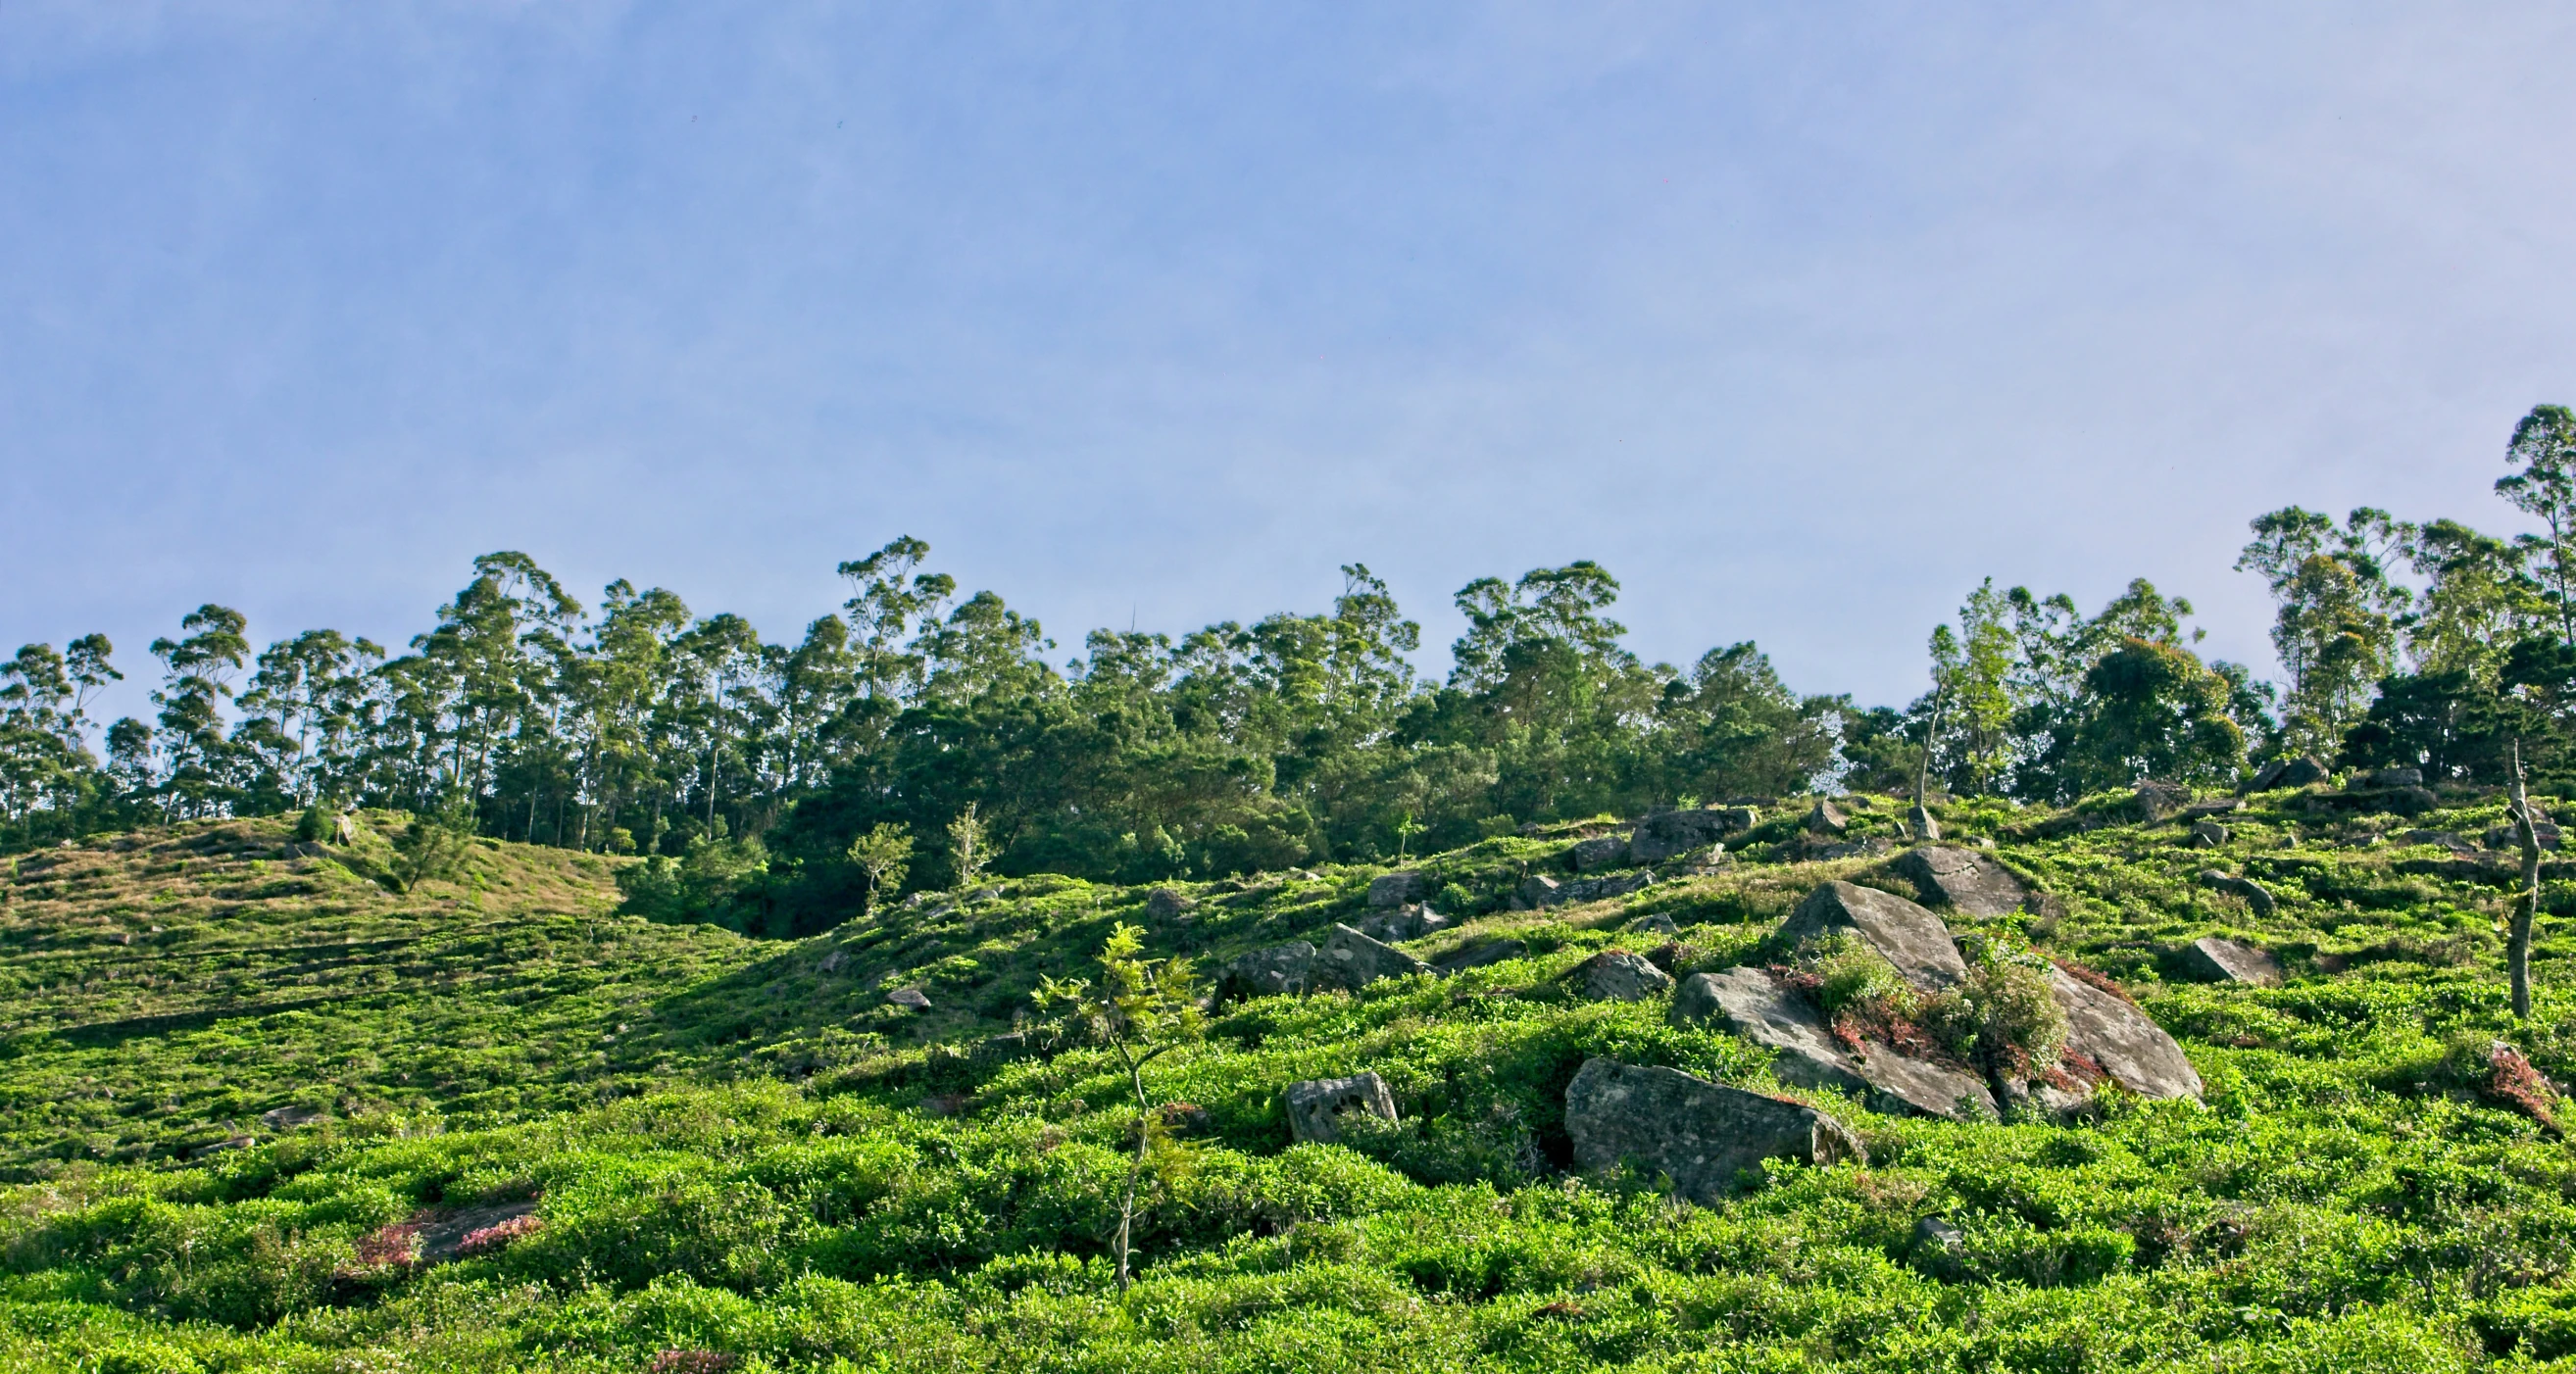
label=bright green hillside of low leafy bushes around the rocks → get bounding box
[0,794,2576,1369]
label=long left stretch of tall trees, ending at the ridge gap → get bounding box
[0,539,1855,933]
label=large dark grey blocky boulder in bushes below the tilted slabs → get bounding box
[1566,1059,1870,1203]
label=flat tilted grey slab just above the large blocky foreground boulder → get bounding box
[1672,969,1997,1121]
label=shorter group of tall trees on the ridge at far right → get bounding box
[1911,405,2576,799]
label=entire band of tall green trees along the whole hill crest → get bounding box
[15,408,2576,936]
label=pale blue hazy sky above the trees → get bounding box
[0,0,2576,721]
